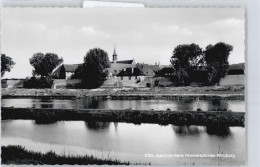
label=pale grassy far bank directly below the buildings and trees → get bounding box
[2,86,245,98]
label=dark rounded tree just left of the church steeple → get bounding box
[82,48,110,89]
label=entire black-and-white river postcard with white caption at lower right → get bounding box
[1,7,247,166]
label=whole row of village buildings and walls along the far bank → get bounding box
[1,45,245,89]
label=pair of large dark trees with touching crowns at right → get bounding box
[170,42,233,85]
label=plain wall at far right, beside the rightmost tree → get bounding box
[219,75,245,86]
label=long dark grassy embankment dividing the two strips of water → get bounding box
[1,107,245,127]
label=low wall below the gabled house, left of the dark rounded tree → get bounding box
[52,79,82,89]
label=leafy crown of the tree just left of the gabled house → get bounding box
[29,53,63,77]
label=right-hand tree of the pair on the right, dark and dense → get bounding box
[205,42,233,85]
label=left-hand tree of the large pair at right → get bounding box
[171,43,203,85]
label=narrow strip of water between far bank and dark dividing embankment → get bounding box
[1,99,245,112]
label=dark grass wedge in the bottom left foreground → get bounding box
[1,145,138,165]
